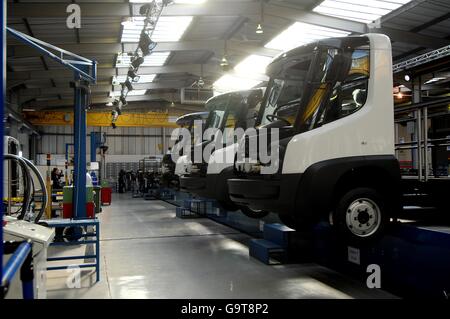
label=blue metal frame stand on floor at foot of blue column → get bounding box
[46,218,100,282]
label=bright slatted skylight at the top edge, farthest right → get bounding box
[313,0,411,23]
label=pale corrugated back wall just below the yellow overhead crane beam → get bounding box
[37,126,173,156]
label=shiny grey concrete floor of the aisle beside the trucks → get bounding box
[47,194,394,299]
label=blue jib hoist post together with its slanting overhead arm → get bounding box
[3,27,97,219]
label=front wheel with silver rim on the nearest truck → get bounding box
[333,187,389,242]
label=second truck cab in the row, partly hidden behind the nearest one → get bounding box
[180,89,266,214]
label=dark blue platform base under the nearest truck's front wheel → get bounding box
[313,223,450,299]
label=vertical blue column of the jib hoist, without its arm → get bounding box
[73,74,87,219]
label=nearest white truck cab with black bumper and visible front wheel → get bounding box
[228,34,400,240]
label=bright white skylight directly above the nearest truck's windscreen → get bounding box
[265,22,350,51]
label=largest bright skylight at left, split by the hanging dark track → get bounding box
[121,16,192,42]
